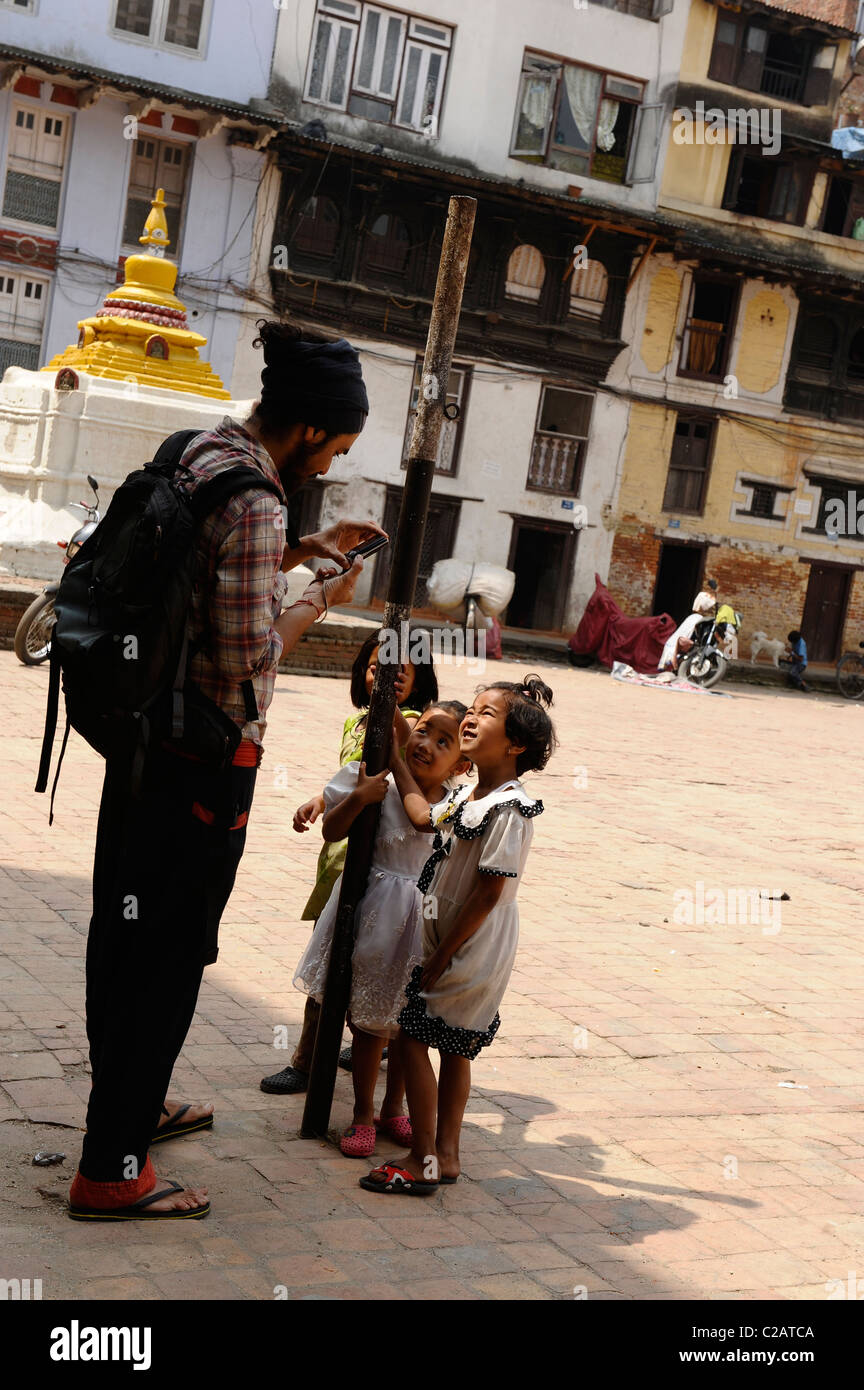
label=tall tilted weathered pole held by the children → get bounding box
[300,197,476,1138]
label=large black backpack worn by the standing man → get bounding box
[36,430,299,823]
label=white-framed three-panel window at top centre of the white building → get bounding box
[306,0,453,135]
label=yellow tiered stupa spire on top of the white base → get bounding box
[42,188,229,400]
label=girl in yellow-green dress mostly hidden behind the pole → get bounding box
[261,632,438,1095]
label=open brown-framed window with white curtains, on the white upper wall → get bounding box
[510,53,645,183]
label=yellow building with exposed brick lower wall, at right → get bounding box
[607,0,864,662]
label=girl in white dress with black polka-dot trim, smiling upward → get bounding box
[360,677,556,1197]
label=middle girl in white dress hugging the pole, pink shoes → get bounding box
[294,701,470,1158]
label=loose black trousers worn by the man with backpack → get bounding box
[79,753,256,1183]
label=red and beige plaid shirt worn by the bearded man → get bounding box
[183,416,286,744]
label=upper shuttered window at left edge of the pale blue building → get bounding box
[3,104,69,228]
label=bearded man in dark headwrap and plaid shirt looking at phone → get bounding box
[69,321,382,1220]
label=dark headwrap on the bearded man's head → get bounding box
[258,329,369,435]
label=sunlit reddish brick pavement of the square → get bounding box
[0,652,864,1300]
